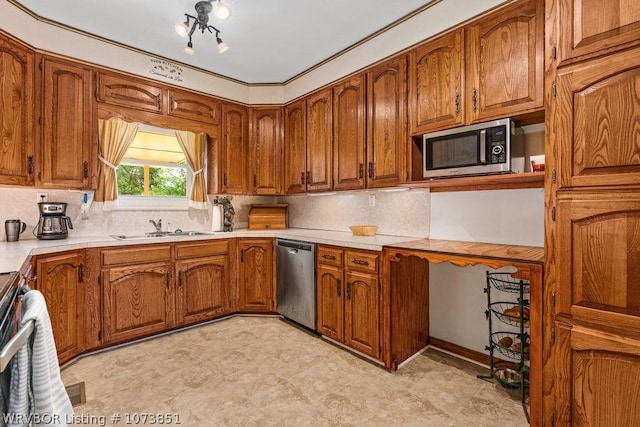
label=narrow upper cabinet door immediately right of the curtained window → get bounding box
[221,102,249,194]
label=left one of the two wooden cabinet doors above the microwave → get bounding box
[409,30,464,134]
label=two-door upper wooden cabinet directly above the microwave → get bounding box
[409,0,544,135]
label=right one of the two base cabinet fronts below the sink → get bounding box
[175,240,230,326]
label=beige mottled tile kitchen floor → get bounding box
[62,317,528,427]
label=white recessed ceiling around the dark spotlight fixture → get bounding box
[10,0,440,84]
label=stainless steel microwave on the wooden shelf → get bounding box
[422,119,515,178]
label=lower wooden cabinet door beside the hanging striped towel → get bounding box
[36,251,84,363]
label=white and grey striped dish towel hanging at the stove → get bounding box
[8,290,73,426]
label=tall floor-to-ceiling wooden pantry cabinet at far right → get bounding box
[543,0,640,427]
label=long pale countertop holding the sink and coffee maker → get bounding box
[0,228,416,272]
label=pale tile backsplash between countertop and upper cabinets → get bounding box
[0,187,430,240]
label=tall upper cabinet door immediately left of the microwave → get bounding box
[365,56,408,187]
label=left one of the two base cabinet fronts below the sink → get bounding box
[100,245,175,344]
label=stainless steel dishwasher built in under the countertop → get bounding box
[276,239,316,331]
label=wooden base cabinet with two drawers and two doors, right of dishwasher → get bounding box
[317,245,380,359]
